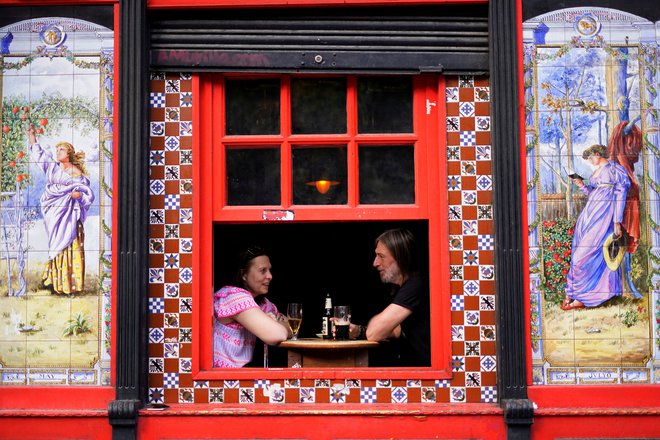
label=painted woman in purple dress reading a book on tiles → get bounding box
[562,145,634,310]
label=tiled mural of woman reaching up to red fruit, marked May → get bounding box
[0,18,114,385]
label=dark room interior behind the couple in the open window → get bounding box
[213,221,428,367]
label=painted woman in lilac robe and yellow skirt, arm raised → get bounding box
[26,124,94,295]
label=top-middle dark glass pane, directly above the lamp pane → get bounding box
[291,78,346,134]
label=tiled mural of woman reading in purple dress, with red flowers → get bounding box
[523,8,660,384]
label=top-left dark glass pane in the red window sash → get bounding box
[225,79,280,135]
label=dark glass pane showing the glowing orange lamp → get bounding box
[291,146,347,205]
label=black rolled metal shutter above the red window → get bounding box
[149,4,488,75]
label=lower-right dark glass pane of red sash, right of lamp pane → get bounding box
[359,145,415,204]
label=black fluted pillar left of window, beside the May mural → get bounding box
[109,0,149,440]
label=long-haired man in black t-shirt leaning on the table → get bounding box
[350,229,431,366]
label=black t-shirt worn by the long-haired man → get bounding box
[392,275,431,367]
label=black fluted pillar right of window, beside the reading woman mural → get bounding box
[488,0,534,439]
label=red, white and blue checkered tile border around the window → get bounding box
[148,73,497,404]
